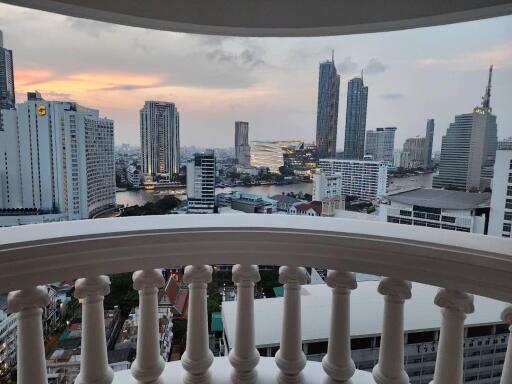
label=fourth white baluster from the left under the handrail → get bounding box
[181,265,213,384]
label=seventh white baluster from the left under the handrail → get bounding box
[322,271,357,382]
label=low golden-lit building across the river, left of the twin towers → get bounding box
[251,140,304,173]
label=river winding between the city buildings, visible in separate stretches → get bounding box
[116,173,434,206]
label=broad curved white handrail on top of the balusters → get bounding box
[0,215,512,302]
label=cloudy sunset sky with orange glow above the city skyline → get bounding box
[0,4,512,149]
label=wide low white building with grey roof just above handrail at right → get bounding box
[379,188,491,234]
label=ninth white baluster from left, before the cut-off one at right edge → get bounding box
[431,288,475,384]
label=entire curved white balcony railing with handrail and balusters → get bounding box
[0,215,512,384]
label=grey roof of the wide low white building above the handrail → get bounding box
[385,188,491,209]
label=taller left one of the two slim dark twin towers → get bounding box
[316,53,340,159]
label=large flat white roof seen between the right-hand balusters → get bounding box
[222,281,505,347]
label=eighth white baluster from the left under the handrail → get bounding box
[373,277,411,384]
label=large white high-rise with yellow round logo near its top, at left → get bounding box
[0,93,115,220]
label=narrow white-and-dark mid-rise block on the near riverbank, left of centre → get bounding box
[187,149,215,213]
